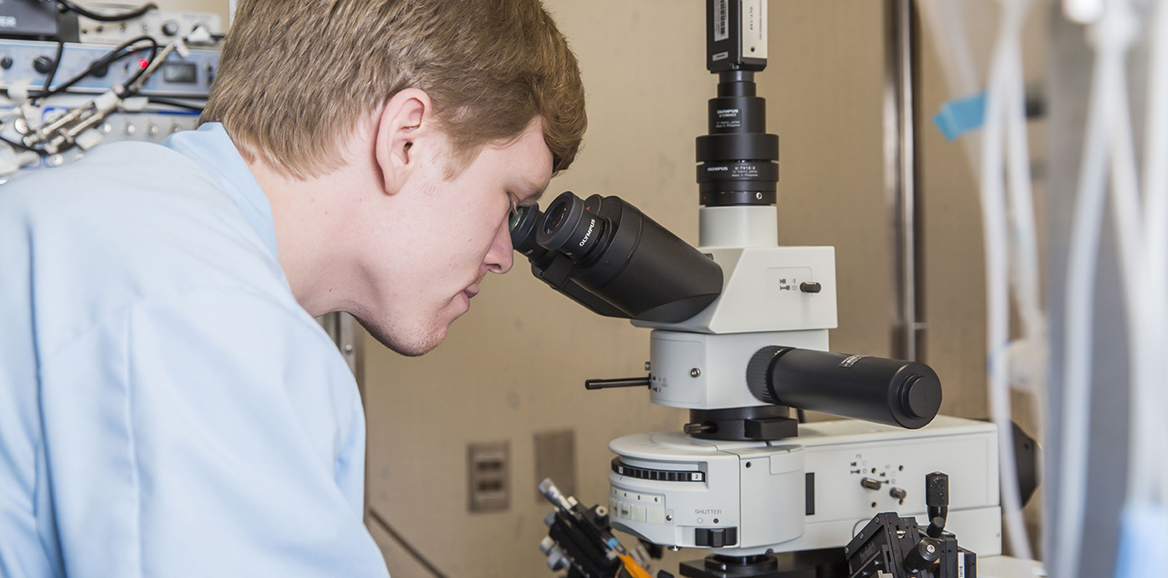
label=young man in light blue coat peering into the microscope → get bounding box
[0,0,585,577]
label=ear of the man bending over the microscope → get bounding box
[374,89,433,195]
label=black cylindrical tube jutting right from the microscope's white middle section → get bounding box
[746,347,941,430]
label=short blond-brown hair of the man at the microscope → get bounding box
[200,0,588,179]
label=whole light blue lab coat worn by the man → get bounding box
[0,124,387,578]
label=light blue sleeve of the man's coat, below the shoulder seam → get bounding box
[41,290,388,578]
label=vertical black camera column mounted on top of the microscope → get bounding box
[697,0,779,207]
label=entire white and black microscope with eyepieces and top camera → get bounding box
[510,0,1001,578]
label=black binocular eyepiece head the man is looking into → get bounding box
[510,191,722,323]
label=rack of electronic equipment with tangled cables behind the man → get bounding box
[0,0,220,183]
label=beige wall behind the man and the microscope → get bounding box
[366,0,1004,578]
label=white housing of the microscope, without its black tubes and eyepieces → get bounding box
[609,207,1001,557]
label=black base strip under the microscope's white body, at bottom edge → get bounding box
[679,548,848,578]
